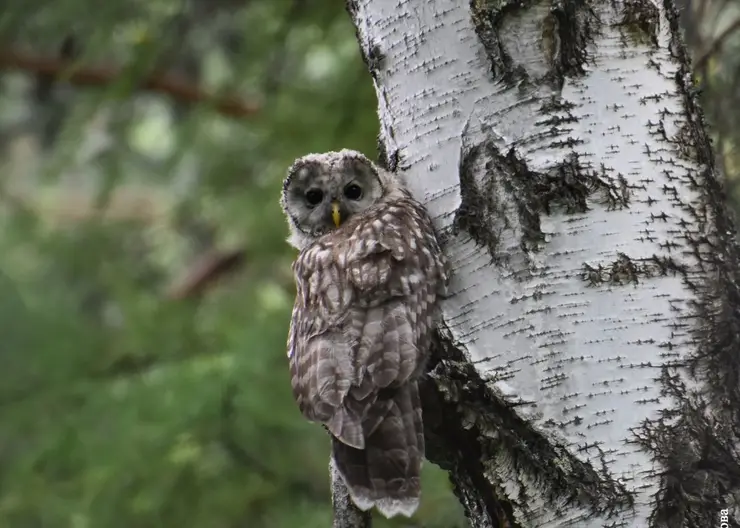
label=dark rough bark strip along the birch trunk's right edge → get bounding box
[635,0,740,527]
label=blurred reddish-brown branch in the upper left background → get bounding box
[0,48,259,118]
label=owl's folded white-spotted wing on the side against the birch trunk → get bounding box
[347,213,438,396]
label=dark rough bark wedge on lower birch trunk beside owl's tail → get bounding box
[422,333,634,528]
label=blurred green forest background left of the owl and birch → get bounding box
[0,0,463,528]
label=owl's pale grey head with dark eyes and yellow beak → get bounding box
[280,150,393,249]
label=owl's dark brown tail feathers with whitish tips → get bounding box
[332,382,424,518]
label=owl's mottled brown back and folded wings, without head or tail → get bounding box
[289,202,446,449]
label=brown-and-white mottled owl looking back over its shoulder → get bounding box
[280,150,448,517]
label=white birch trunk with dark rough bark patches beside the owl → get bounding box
[339,0,740,527]
